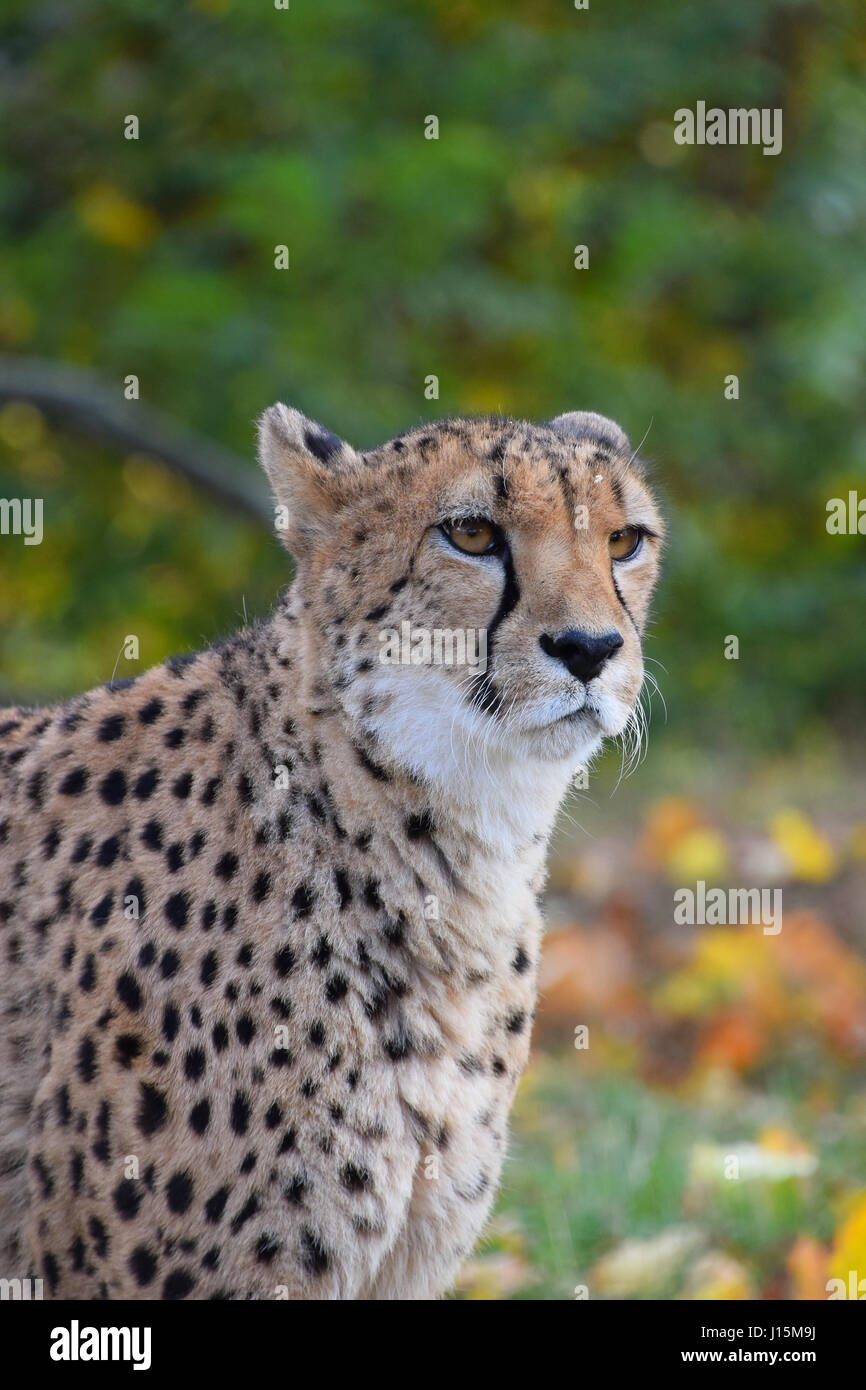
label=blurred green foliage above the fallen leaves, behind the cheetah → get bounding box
[0,0,866,746]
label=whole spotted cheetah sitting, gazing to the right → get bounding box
[0,404,663,1300]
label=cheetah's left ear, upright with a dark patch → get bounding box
[259,403,360,559]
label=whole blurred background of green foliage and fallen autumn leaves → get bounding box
[0,0,866,1297]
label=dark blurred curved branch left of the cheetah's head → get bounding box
[0,356,274,531]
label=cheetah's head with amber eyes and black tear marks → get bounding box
[261,406,663,773]
